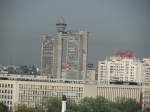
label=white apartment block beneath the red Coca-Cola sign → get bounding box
[98,57,142,83]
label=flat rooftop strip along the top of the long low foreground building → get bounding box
[0,74,150,86]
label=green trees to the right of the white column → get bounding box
[66,96,140,112]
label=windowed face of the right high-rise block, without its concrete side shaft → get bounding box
[66,34,83,79]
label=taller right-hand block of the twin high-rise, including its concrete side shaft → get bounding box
[66,30,88,80]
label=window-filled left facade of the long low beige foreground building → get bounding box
[0,80,84,109]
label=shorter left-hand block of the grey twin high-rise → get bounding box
[41,33,57,78]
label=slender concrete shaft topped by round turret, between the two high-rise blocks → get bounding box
[56,17,67,79]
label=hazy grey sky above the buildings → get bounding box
[0,0,150,66]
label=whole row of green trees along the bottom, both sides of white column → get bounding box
[0,96,148,112]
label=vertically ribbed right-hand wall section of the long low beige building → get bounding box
[97,84,142,103]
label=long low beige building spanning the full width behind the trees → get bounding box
[0,74,150,110]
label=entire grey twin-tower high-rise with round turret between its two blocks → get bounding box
[41,17,89,80]
